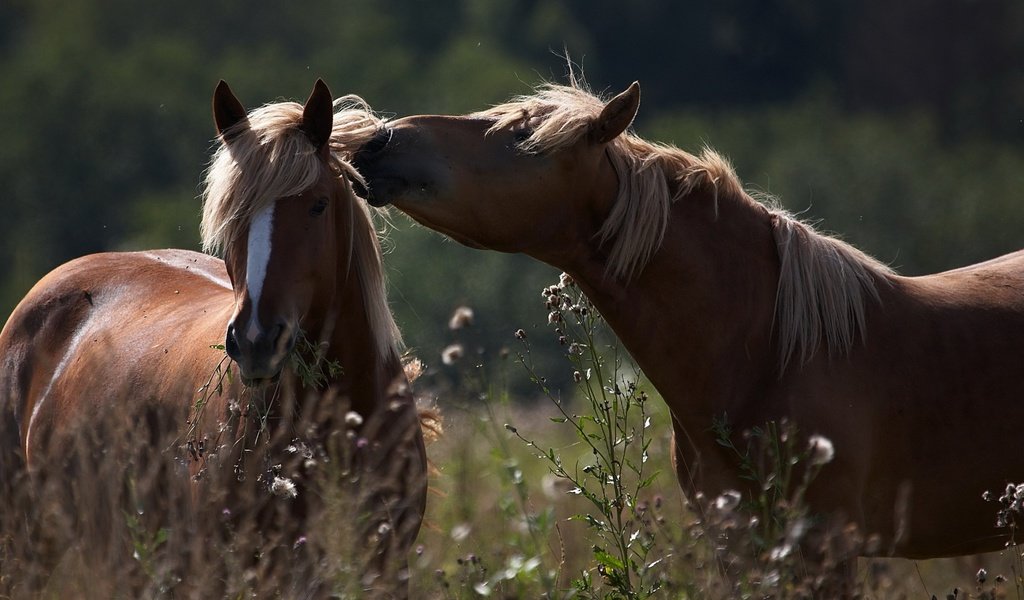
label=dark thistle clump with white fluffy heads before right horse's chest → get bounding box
[701,415,879,598]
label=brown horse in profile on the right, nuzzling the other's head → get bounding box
[354,82,1024,558]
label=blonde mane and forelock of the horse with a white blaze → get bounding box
[200,95,401,357]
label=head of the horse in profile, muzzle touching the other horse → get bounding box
[354,83,640,262]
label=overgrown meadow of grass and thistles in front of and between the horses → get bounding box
[0,282,1024,599]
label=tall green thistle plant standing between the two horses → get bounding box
[506,273,664,599]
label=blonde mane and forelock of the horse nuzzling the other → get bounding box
[475,79,892,372]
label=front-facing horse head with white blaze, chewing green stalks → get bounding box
[208,80,353,381]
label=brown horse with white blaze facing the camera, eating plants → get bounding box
[0,81,426,597]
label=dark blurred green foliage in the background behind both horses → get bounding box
[0,0,1024,395]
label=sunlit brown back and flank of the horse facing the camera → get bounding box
[0,250,230,466]
